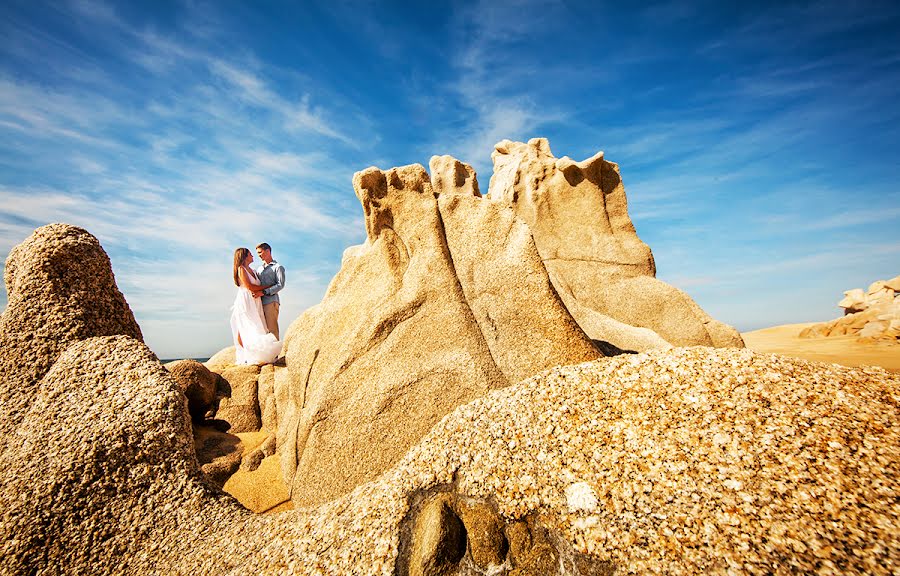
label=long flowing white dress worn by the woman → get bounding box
[231,268,281,364]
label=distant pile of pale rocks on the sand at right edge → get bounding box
[800,276,900,344]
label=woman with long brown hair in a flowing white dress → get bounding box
[231,248,281,364]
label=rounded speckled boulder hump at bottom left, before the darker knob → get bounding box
[0,336,246,574]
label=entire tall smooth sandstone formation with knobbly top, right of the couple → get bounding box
[209,140,742,506]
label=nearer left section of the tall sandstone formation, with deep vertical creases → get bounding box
[276,156,600,506]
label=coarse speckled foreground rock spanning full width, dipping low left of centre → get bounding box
[0,337,900,576]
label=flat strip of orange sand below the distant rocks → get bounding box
[741,322,900,372]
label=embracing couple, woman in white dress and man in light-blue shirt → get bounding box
[231,242,284,364]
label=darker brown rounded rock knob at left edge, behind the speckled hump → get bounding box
[0,224,142,439]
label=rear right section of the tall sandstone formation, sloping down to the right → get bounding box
[488,138,743,350]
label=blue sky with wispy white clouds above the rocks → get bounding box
[0,0,900,358]
